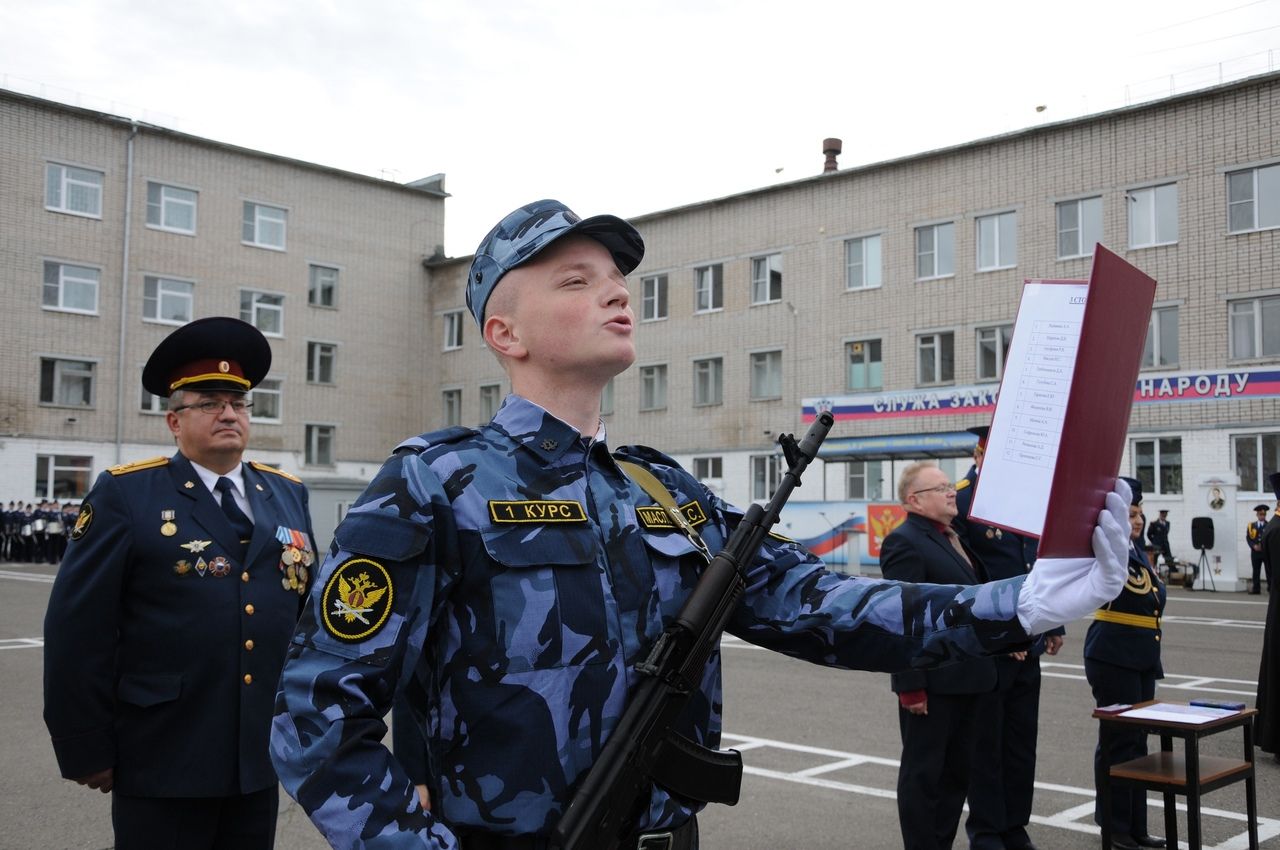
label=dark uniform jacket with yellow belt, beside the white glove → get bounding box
[1084,545,1166,678]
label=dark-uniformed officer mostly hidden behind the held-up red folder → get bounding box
[951,425,1065,850]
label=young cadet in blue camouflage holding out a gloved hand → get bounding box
[271,201,1128,850]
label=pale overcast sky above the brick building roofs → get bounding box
[0,0,1280,256]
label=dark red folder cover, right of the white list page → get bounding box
[1039,245,1156,558]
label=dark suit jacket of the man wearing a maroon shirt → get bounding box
[881,513,998,694]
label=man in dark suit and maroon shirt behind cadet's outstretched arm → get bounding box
[881,463,996,850]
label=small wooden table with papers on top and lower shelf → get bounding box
[1093,700,1258,850]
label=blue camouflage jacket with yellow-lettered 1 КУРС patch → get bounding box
[271,396,1028,847]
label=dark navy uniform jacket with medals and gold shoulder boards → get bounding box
[45,454,315,796]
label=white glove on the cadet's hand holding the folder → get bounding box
[1018,479,1130,635]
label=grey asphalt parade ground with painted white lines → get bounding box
[0,565,1280,850]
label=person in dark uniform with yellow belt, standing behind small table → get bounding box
[1084,479,1165,850]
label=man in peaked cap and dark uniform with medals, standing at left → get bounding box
[45,316,316,850]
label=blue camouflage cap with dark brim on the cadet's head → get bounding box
[467,200,644,328]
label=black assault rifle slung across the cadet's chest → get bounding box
[550,412,835,850]
